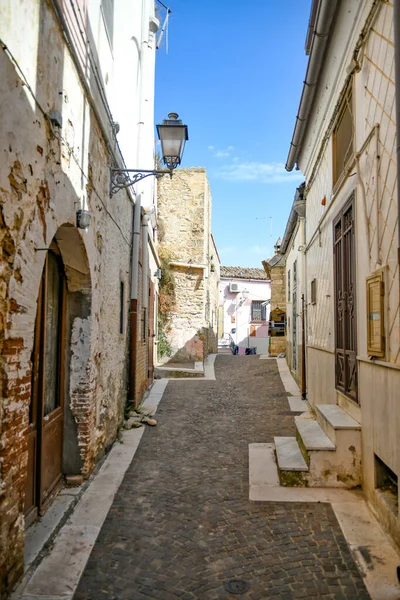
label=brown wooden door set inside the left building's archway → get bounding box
[25,245,65,524]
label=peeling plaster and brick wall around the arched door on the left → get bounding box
[0,0,132,596]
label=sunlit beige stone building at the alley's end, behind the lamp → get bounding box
[158,167,220,362]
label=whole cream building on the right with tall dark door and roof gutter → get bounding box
[286,0,400,543]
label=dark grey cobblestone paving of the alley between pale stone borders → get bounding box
[74,355,369,600]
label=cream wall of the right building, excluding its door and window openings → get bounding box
[292,0,400,542]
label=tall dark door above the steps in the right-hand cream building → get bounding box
[333,196,358,402]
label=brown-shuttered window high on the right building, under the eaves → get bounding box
[332,88,354,185]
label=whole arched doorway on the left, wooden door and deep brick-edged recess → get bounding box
[25,224,92,526]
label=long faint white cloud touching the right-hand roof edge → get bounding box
[217,162,304,183]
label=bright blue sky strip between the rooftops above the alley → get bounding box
[155,0,311,267]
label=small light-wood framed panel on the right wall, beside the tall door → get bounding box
[367,271,385,358]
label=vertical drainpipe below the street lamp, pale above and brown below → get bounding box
[129,194,142,402]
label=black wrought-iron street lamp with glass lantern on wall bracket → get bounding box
[110,113,189,197]
